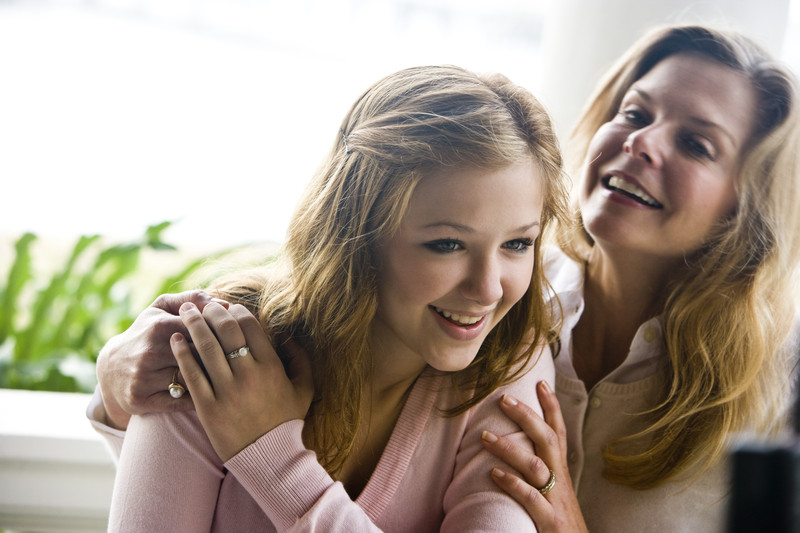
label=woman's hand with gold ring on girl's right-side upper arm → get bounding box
[483,381,588,533]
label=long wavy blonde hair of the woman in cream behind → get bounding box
[560,26,800,488]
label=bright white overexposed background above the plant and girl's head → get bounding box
[0,0,800,249]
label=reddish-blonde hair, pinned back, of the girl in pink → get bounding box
[209,66,567,475]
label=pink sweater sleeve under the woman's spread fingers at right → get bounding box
[441,349,555,533]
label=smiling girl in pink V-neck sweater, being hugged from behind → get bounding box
[98,67,565,532]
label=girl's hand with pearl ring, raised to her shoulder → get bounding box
[171,303,314,462]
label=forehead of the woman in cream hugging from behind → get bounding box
[629,53,757,146]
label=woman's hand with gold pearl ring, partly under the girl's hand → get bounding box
[97,291,228,429]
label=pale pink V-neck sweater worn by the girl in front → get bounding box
[97,351,555,533]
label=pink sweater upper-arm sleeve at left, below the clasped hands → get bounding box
[108,412,224,532]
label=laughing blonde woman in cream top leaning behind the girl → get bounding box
[484,26,800,532]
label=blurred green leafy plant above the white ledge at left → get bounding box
[0,222,250,392]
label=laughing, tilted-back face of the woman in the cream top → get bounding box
[580,54,756,259]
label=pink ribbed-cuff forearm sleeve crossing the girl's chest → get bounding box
[225,420,380,532]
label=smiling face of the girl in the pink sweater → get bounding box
[373,159,542,371]
